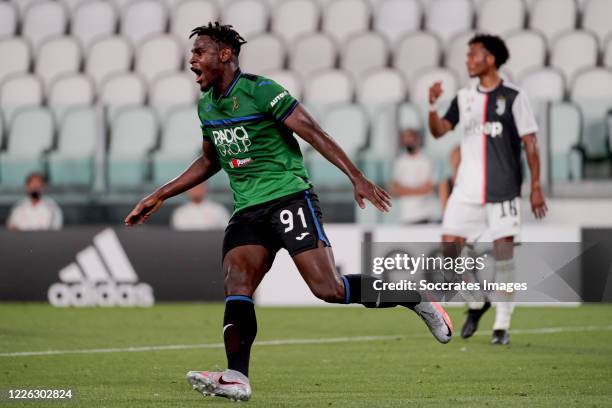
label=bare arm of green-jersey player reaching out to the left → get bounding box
[124,140,221,226]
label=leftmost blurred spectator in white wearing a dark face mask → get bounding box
[6,173,64,231]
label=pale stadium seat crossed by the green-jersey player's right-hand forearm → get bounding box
[309,104,368,188]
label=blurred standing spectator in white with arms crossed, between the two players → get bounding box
[389,129,435,224]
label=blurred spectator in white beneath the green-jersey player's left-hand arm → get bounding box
[171,182,229,230]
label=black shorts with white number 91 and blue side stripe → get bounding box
[223,189,331,258]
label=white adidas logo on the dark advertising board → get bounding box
[47,228,155,307]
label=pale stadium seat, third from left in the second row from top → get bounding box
[85,36,132,88]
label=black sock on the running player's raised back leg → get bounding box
[342,275,421,308]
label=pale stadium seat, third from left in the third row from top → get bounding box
[98,74,147,120]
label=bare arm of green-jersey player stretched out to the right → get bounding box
[285,105,391,212]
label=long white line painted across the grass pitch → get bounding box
[0,325,612,357]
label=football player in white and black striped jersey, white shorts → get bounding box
[429,34,547,344]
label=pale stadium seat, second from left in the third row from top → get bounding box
[47,74,95,121]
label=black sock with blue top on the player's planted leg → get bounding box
[223,295,257,377]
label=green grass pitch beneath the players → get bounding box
[0,303,612,408]
